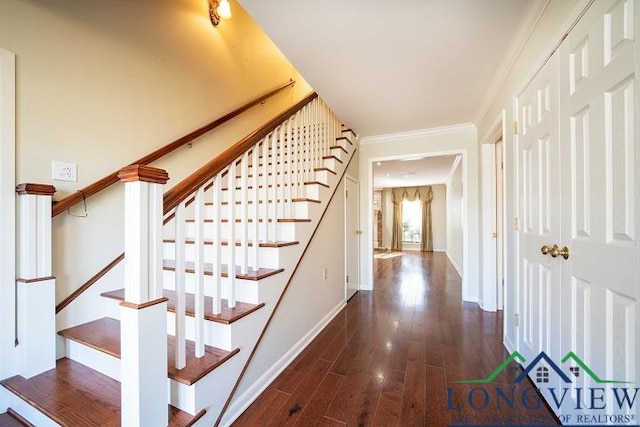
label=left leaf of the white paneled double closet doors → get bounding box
[514,55,561,368]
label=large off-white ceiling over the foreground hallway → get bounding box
[239,0,546,136]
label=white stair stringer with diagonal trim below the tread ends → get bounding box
[175,137,356,426]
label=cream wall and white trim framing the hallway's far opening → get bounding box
[360,125,480,301]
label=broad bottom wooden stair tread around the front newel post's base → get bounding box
[0,358,204,427]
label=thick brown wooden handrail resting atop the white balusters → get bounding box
[163,92,318,215]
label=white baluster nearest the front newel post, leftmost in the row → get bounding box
[173,202,186,369]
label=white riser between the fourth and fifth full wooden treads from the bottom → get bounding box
[163,242,280,268]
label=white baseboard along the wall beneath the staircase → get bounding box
[224,301,347,425]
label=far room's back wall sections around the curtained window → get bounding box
[382,184,447,251]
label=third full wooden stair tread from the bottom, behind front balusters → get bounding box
[100,289,264,325]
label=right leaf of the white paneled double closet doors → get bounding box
[556,0,640,415]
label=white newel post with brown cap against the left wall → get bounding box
[16,184,56,378]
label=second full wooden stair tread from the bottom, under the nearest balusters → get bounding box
[58,317,239,385]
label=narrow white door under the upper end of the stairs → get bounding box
[344,176,362,299]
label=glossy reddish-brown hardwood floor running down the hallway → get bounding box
[234,253,557,427]
